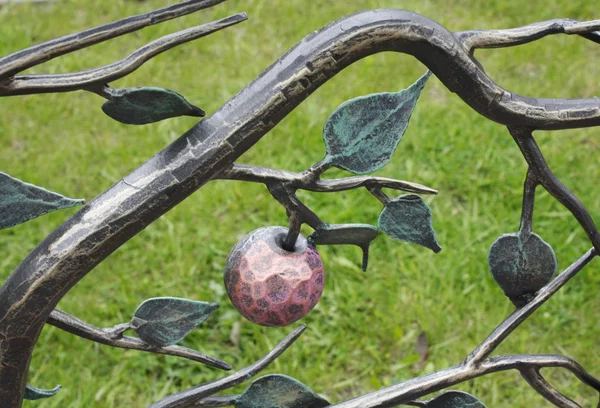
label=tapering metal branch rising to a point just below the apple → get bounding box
[150,325,306,408]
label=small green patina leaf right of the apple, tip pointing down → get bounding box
[379,194,442,253]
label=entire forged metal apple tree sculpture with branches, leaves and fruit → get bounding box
[0,0,600,408]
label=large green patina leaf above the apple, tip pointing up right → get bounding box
[323,71,431,174]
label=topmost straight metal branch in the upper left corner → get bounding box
[0,0,225,79]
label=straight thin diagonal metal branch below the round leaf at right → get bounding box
[463,248,597,366]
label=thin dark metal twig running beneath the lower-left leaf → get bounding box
[47,309,231,370]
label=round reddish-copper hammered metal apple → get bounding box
[224,227,325,326]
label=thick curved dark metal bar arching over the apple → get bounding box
[0,10,600,407]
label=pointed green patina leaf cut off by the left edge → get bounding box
[0,172,84,229]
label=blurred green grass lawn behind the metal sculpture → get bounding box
[0,0,600,408]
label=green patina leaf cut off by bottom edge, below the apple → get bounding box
[235,374,331,408]
